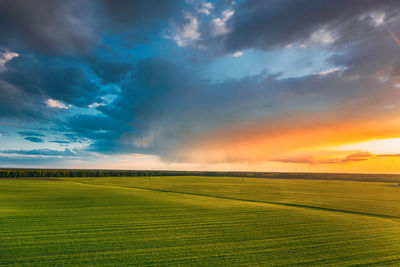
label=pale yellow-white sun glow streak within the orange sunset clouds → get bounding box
[335,138,400,154]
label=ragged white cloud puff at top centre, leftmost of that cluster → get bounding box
[166,15,201,46]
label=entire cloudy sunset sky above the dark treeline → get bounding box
[0,0,400,173]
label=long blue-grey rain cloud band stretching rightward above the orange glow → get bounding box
[67,55,394,158]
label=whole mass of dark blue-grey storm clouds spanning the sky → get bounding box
[0,0,400,166]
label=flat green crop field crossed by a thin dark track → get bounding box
[0,177,400,266]
